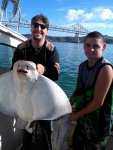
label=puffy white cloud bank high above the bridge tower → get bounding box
[66,7,113,22]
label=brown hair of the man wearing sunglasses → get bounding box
[31,14,49,29]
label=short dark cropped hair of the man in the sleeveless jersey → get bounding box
[84,31,105,43]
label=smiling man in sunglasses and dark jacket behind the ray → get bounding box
[12,14,60,150]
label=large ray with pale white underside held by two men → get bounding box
[0,60,72,128]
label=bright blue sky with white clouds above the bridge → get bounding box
[1,0,113,36]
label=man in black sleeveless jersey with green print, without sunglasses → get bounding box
[70,31,113,150]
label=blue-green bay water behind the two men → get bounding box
[0,42,113,97]
